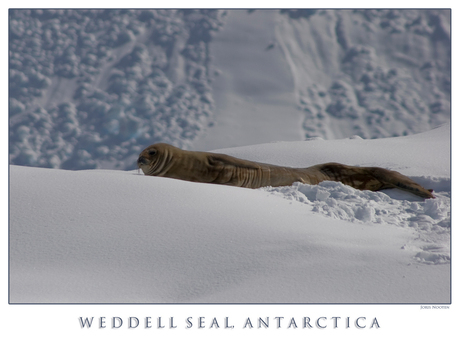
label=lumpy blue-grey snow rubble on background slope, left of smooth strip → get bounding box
[9,9,225,169]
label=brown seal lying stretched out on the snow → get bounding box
[137,143,434,198]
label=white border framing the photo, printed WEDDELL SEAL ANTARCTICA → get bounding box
[0,0,459,340]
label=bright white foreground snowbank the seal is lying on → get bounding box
[10,125,451,304]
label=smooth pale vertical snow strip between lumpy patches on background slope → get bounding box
[193,10,302,150]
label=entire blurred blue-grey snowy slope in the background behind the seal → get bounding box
[9,9,451,170]
